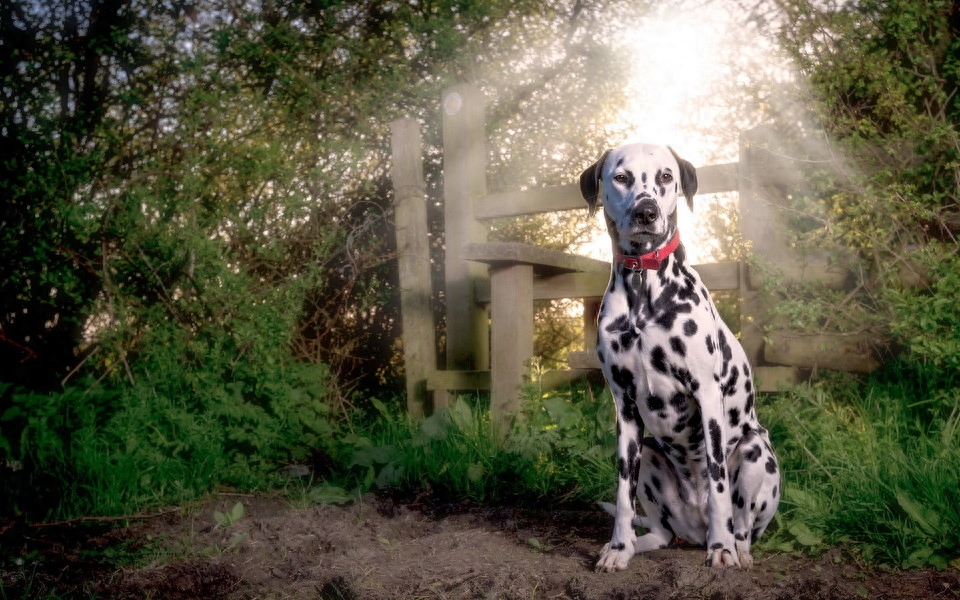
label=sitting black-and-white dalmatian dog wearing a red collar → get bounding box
[580,144,780,572]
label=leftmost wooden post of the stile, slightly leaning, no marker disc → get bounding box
[390,119,437,417]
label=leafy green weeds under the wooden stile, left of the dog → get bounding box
[326,384,616,503]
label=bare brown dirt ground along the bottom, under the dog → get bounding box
[0,495,960,600]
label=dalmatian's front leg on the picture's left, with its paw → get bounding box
[596,398,643,573]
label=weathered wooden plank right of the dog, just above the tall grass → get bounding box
[763,330,886,373]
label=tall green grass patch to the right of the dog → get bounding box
[760,369,960,569]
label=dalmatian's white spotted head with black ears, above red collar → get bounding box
[580,144,697,253]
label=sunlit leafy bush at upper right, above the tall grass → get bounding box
[757,0,960,372]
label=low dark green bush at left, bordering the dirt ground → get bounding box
[0,273,338,518]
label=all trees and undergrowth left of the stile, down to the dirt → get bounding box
[0,0,636,518]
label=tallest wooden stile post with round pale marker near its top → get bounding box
[443,85,490,370]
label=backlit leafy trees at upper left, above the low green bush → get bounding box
[0,0,644,398]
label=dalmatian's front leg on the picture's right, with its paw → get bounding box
[700,386,740,567]
